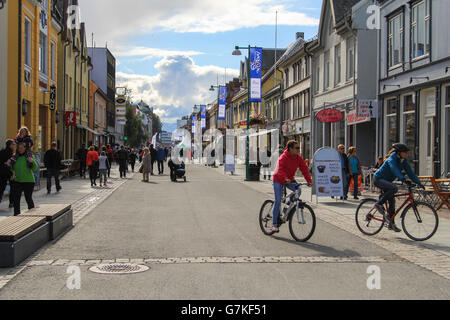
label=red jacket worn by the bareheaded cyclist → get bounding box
[273,150,312,184]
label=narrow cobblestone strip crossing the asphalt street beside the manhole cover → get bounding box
[27,256,402,267]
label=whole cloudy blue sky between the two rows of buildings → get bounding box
[79,0,322,131]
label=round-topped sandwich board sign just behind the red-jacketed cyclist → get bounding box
[314,147,344,197]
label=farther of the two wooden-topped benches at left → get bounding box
[19,204,73,240]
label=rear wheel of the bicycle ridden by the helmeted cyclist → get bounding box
[355,199,384,236]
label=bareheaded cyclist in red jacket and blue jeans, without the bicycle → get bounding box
[271,140,312,232]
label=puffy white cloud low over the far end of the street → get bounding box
[116,55,239,123]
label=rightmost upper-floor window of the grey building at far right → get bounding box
[411,0,430,59]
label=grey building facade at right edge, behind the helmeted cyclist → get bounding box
[379,0,450,177]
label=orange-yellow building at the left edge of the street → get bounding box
[2,0,62,155]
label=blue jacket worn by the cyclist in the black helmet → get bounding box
[374,152,421,185]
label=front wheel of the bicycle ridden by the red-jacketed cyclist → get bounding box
[289,203,316,242]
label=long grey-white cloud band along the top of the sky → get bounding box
[80,0,319,47]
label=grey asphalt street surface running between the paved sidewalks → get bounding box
[0,166,450,299]
